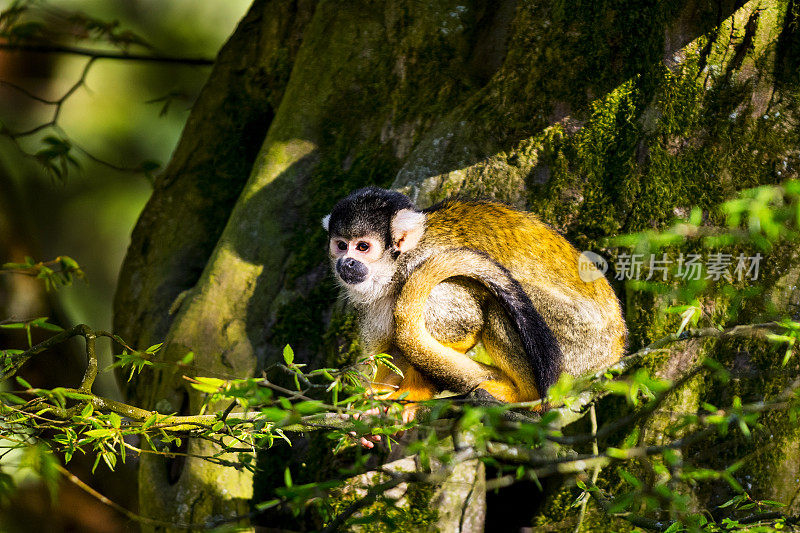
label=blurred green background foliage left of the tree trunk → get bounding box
[0,0,250,389]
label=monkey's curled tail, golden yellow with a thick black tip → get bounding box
[395,248,563,398]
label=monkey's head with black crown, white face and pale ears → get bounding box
[322,187,425,303]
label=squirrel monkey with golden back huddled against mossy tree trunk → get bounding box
[322,187,626,418]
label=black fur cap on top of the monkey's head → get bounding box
[328,187,414,247]
